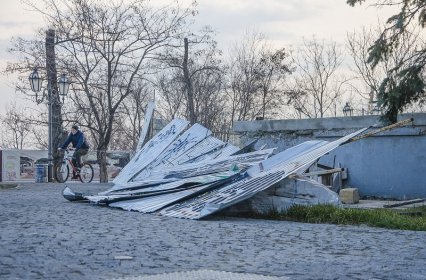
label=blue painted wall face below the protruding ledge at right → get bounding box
[320,136,426,199]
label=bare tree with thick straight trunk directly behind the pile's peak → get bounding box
[154,28,224,130]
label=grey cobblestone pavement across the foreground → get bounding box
[0,183,426,279]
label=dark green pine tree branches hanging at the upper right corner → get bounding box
[347,0,426,123]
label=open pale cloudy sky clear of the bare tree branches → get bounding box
[0,0,391,114]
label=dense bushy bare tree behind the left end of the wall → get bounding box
[227,33,291,121]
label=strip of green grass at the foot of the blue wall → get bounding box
[256,205,426,231]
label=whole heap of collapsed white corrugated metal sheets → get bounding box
[63,119,366,219]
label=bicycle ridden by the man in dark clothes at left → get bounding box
[55,149,93,183]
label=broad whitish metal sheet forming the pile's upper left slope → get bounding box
[113,119,189,188]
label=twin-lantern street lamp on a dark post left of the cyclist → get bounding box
[29,68,70,182]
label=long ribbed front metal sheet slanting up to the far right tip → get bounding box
[160,129,366,219]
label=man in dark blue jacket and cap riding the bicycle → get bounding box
[59,125,89,179]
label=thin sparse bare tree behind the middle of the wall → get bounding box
[288,37,346,118]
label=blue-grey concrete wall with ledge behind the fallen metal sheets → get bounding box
[233,113,426,199]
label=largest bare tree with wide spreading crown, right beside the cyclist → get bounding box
[10,0,193,182]
